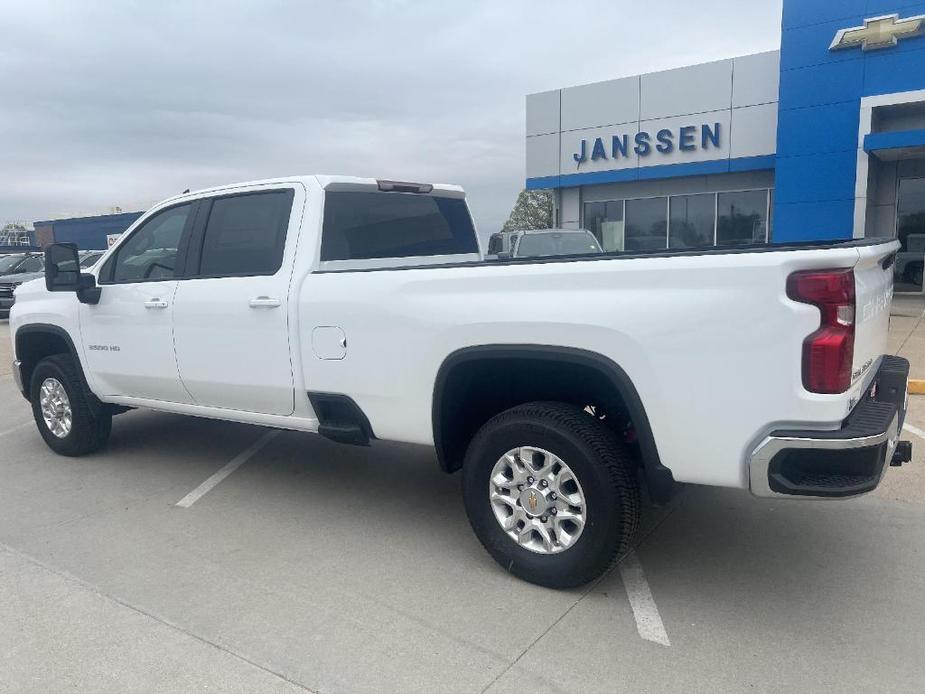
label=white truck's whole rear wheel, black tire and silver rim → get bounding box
[463,402,639,588]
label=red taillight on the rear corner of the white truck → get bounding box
[787,270,854,393]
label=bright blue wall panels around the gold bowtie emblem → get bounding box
[774,0,925,241]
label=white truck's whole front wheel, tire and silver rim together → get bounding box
[29,354,112,456]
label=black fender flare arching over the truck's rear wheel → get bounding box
[432,345,674,503]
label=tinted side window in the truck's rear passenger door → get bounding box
[199,190,293,277]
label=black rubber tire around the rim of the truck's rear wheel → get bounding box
[463,402,640,588]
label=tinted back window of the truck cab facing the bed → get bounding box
[321,191,478,260]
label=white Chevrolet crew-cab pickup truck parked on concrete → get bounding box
[11,176,911,587]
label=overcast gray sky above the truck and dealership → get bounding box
[0,0,781,234]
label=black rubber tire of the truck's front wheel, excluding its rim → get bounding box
[29,354,112,456]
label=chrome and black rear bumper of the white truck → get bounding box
[749,356,912,498]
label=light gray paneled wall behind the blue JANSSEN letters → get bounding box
[527,51,780,185]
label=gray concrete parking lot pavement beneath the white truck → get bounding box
[0,315,925,694]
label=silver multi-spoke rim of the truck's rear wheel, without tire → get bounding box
[488,446,587,554]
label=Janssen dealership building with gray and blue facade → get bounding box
[526,0,925,291]
